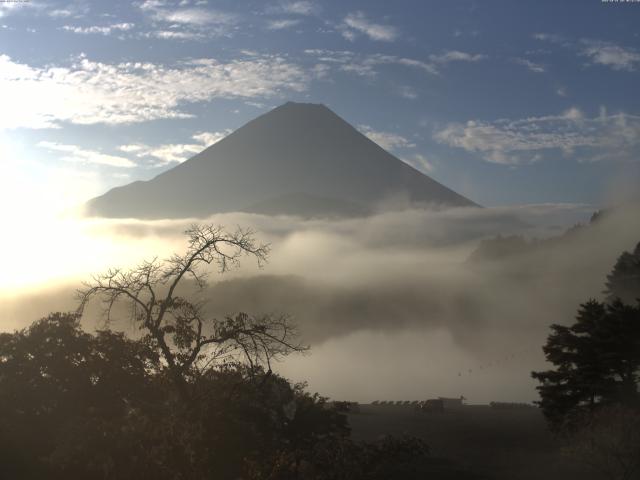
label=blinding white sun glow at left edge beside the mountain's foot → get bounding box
[0,135,172,296]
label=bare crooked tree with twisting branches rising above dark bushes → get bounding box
[77,225,307,400]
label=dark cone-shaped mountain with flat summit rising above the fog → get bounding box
[87,102,475,218]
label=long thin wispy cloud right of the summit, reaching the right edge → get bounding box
[434,108,640,165]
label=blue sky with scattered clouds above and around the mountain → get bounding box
[0,0,640,210]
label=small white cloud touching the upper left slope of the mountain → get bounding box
[118,130,231,166]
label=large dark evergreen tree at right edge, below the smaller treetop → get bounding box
[532,300,640,431]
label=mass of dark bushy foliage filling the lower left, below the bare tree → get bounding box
[0,313,436,480]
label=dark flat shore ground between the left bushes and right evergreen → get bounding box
[349,405,598,480]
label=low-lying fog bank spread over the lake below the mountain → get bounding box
[0,205,640,403]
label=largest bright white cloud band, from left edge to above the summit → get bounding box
[0,55,309,129]
